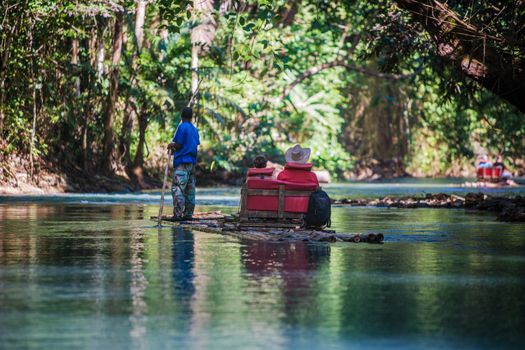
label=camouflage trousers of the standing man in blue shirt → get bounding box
[171,163,195,218]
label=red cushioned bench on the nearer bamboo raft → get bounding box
[239,169,319,221]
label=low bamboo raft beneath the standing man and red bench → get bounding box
[151,211,384,244]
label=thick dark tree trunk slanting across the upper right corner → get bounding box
[395,0,525,113]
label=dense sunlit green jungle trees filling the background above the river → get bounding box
[0,0,525,188]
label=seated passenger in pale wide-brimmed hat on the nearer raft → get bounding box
[277,145,319,186]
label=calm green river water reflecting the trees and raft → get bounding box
[0,182,525,349]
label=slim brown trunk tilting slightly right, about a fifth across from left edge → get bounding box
[101,12,124,173]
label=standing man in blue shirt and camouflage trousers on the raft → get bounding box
[168,107,200,220]
